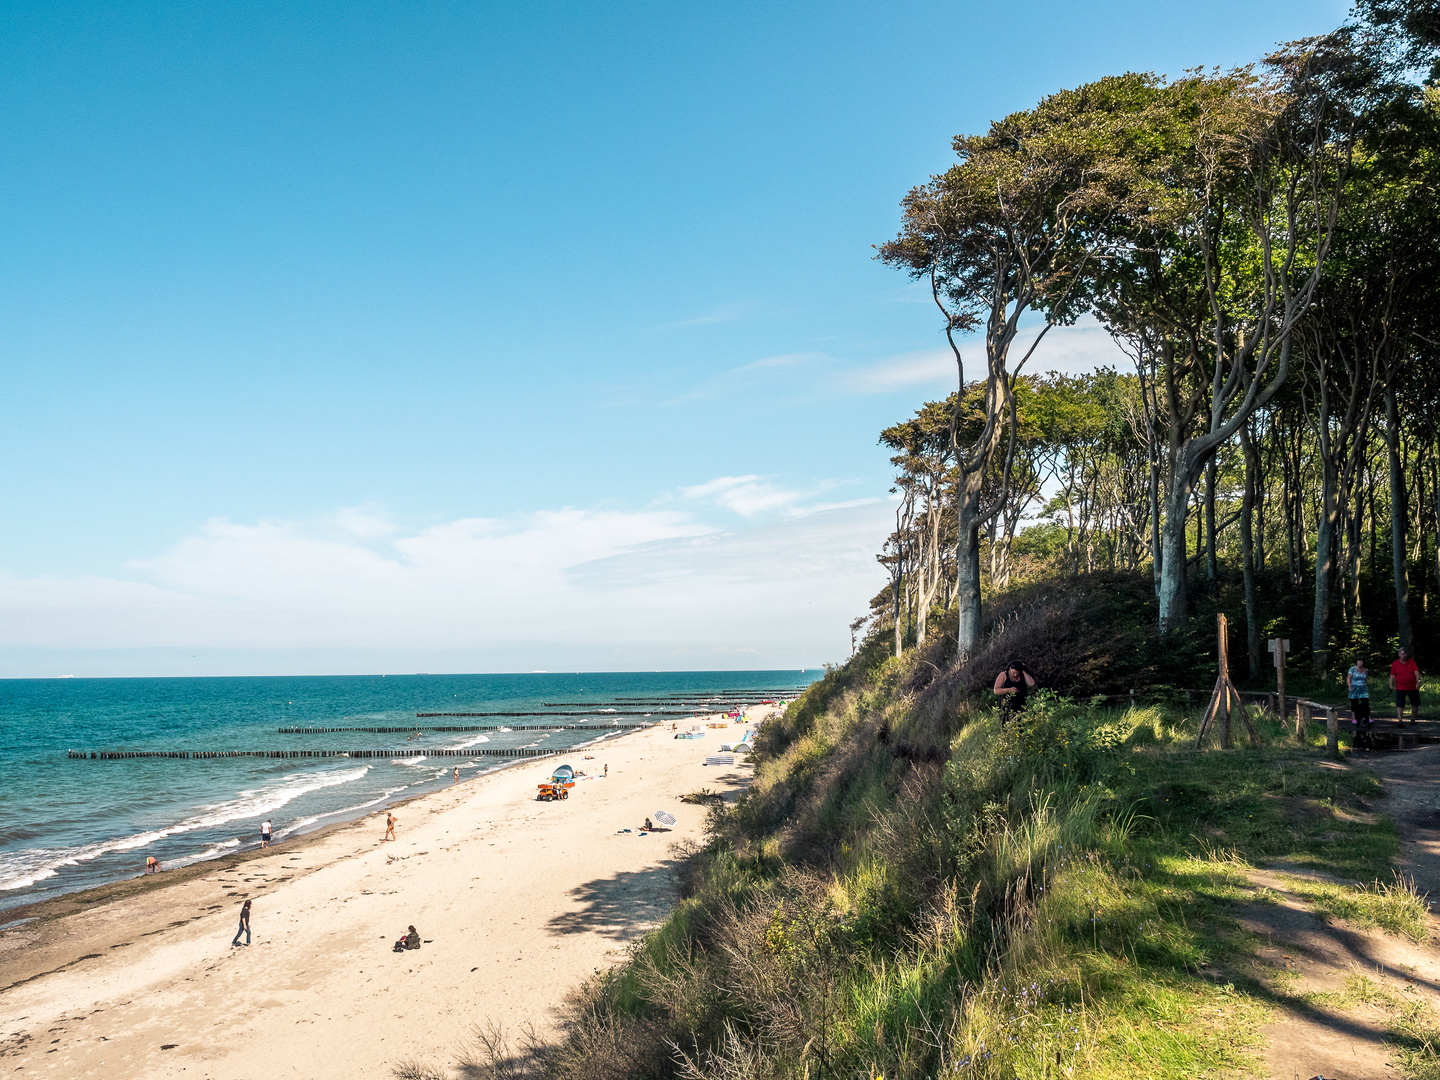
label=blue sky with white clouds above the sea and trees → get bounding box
[0,1,1345,675]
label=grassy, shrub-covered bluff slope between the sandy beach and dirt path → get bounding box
[486,642,1434,1080]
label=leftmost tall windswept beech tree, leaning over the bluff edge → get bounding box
[880,75,1156,655]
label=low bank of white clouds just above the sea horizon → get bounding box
[0,492,890,675]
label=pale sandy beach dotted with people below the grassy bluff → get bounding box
[0,708,766,1080]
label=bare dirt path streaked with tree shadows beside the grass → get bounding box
[1236,746,1440,1080]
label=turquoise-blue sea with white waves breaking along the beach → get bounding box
[0,670,819,910]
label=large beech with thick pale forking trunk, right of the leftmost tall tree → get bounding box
[1096,61,1349,634]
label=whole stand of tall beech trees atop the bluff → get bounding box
[877,0,1440,674]
